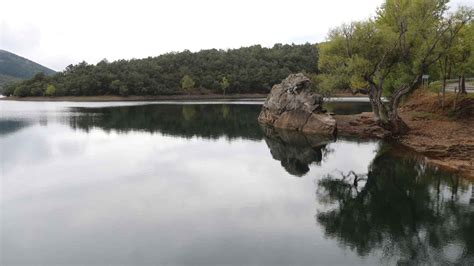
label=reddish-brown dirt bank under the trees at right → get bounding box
[335,91,474,179]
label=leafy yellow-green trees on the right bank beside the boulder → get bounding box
[317,0,474,135]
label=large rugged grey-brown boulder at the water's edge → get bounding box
[258,73,336,135]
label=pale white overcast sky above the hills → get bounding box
[0,0,474,70]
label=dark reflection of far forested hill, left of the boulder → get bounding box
[68,104,263,140]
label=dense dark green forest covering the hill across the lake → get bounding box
[3,43,318,97]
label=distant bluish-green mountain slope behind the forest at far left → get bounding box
[0,49,56,87]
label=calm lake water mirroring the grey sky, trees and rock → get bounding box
[0,101,474,265]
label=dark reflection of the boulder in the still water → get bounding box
[263,127,332,176]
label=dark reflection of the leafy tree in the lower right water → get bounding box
[316,144,474,264]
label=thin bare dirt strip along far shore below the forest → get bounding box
[0,94,267,102]
